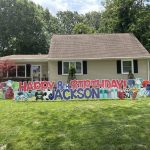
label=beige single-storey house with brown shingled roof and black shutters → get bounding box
[0,33,150,82]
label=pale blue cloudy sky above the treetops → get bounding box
[31,0,104,15]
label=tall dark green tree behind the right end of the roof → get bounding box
[99,0,150,51]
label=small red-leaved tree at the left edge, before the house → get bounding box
[0,60,16,82]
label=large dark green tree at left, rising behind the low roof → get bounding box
[0,0,57,56]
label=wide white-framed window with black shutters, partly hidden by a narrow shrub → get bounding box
[62,62,82,75]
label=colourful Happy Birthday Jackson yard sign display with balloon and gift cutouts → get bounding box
[0,78,150,101]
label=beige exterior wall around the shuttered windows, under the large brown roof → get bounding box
[48,60,148,82]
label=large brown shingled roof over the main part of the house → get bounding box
[49,33,150,59]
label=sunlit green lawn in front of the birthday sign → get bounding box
[0,99,150,150]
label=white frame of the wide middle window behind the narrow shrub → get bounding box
[62,60,83,75]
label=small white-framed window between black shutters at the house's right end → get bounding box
[122,60,133,74]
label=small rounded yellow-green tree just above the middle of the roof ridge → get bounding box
[73,23,95,34]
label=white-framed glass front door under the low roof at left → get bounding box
[31,65,41,81]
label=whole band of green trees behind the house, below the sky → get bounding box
[0,0,150,56]
